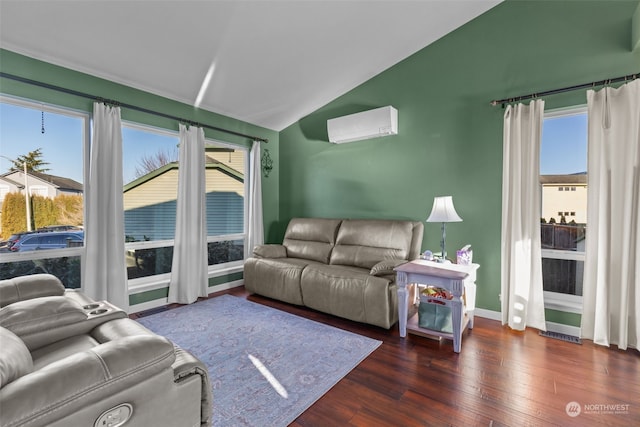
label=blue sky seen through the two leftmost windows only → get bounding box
[0,103,178,184]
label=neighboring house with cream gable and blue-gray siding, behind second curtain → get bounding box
[123,158,244,241]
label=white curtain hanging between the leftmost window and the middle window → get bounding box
[82,103,129,311]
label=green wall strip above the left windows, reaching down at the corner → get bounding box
[0,49,280,237]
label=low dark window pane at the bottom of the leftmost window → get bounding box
[0,256,81,289]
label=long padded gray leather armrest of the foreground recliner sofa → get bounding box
[0,336,175,427]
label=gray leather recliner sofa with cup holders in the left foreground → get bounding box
[0,274,212,427]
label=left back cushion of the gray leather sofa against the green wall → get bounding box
[282,218,342,264]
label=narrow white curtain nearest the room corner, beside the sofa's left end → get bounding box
[244,141,264,258]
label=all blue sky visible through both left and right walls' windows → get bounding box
[0,102,587,184]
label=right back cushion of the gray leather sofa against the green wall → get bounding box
[330,219,422,268]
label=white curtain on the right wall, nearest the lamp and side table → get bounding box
[501,100,546,331]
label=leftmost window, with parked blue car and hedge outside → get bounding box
[0,96,89,288]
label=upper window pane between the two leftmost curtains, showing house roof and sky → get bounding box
[122,127,179,242]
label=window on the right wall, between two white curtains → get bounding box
[540,108,587,308]
